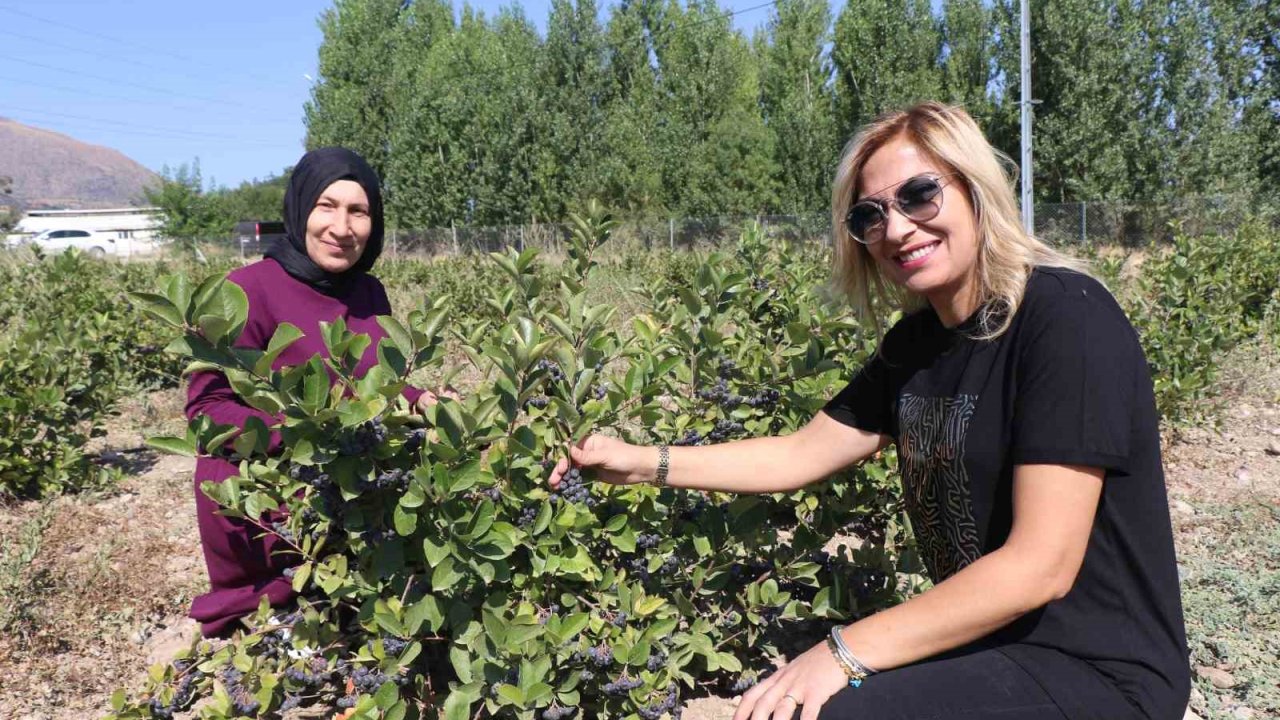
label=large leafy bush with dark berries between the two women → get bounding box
[111,208,915,719]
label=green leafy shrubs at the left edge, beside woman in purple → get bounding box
[0,245,234,501]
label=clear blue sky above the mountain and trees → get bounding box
[0,0,769,186]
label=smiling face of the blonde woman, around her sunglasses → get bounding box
[855,138,978,327]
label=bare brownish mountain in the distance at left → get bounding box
[0,118,160,209]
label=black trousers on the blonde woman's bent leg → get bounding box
[814,650,1068,720]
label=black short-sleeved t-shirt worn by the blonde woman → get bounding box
[826,268,1190,720]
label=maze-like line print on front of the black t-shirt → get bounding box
[897,393,982,582]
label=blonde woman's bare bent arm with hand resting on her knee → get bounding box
[733,465,1103,720]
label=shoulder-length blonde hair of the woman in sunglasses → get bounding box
[831,102,1088,340]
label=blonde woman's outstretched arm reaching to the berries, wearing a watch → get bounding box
[550,413,888,493]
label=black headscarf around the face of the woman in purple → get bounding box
[265,147,383,295]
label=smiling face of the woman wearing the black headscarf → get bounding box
[307,179,374,273]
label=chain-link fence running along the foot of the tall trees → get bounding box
[204,196,1280,258]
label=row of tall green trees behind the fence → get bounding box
[306,0,1280,227]
